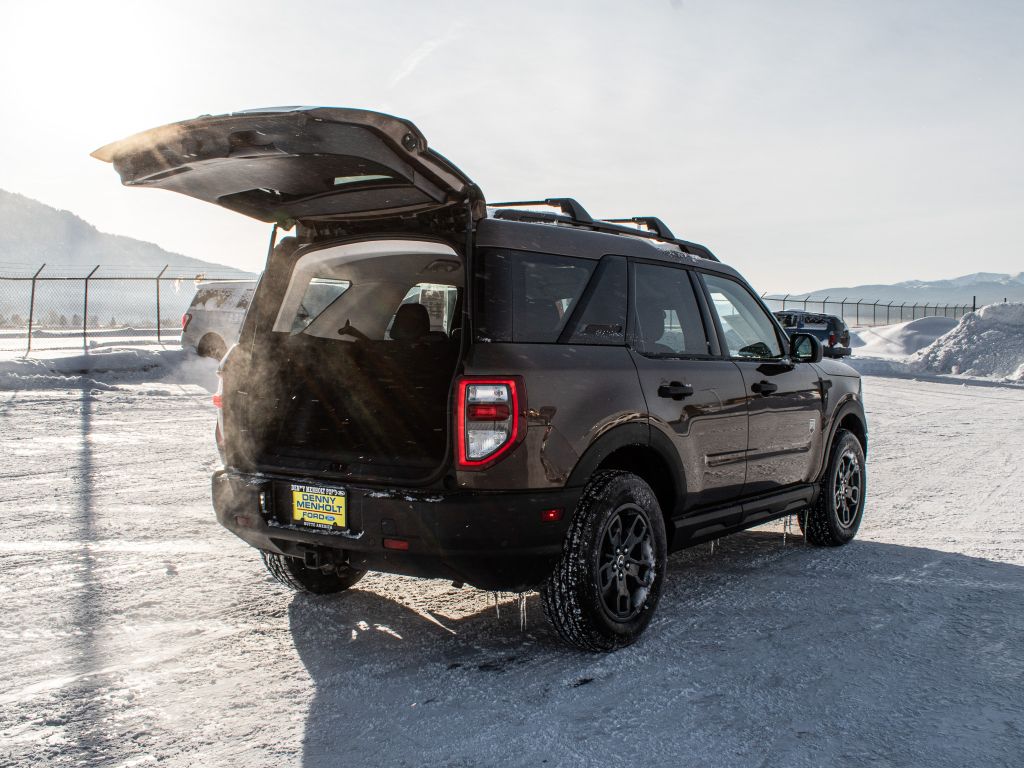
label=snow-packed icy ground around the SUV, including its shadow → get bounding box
[0,378,1024,768]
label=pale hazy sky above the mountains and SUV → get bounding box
[0,0,1024,292]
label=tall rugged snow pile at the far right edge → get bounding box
[913,302,1024,381]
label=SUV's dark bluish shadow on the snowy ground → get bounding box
[289,530,1024,768]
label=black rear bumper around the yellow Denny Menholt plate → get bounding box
[213,470,582,591]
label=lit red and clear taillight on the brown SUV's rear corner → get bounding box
[456,377,526,469]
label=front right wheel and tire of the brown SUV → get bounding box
[798,429,867,547]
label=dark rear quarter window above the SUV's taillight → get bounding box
[476,251,597,343]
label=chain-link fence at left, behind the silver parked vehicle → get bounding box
[0,264,256,354]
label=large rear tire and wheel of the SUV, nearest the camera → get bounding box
[541,471,668,652]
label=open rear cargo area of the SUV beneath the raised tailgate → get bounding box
[224,241,463,481]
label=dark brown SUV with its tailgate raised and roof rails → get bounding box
[95,108,867,650]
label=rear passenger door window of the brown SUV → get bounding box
[633,264,710,356]
